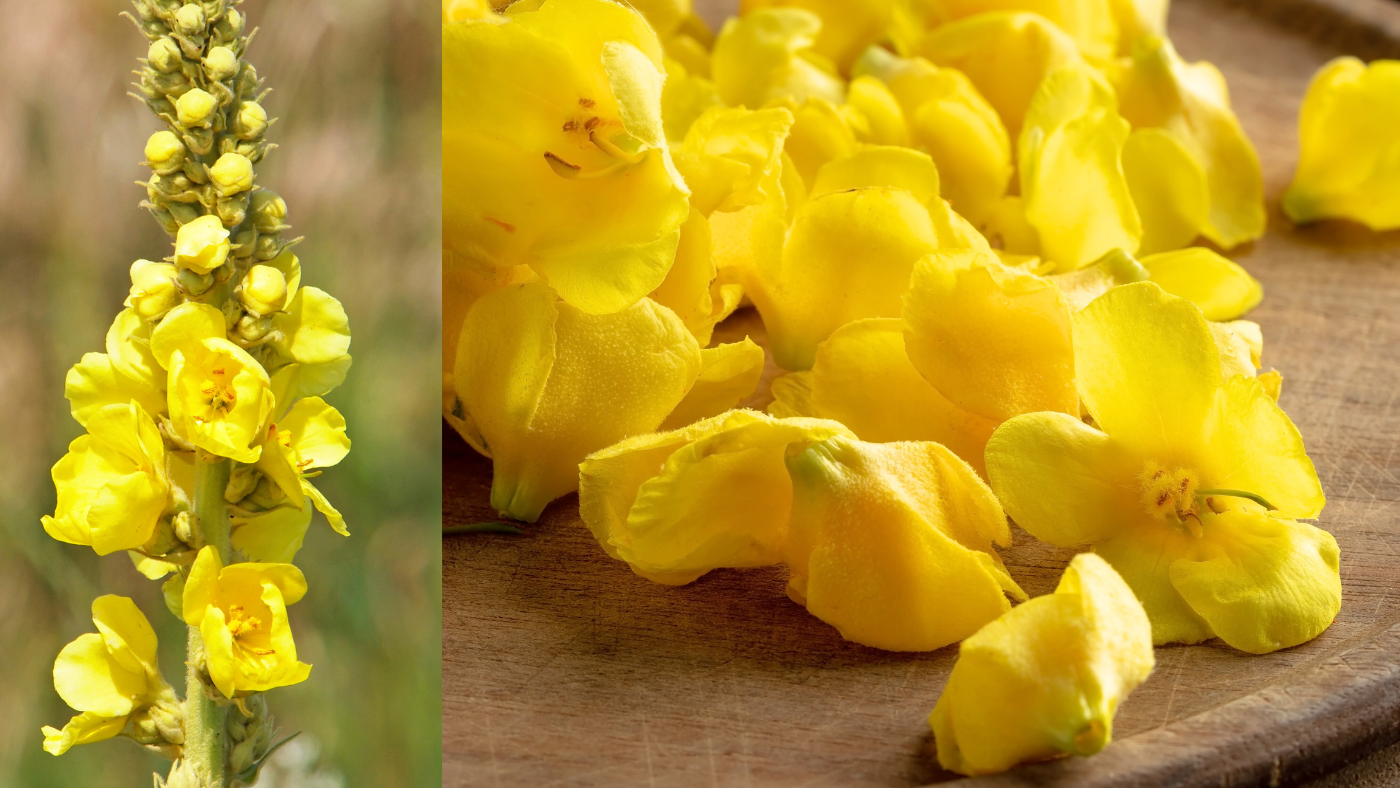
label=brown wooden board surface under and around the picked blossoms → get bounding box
[442,0,1400,788]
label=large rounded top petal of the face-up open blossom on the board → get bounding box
[1074,281,1219,456]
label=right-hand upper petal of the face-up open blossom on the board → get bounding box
[1200,375,1326,519]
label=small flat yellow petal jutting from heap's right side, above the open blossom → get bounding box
[1138,246,1264,321]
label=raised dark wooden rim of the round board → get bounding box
[938,0,1400,788]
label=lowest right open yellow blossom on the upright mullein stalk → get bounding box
[183,546,311,698]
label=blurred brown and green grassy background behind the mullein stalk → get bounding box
[0,0,441,788]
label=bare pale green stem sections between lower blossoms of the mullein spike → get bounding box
[183,449,232,788]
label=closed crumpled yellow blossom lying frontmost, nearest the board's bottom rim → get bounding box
[928,553,1155,774]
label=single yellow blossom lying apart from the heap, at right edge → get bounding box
[1282,57,1400,230]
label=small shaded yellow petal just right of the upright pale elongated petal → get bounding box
[1123,127,1211,255]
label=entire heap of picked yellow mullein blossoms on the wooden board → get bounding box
[442,0,1355,774]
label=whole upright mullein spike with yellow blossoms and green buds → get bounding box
[43,0,350,788]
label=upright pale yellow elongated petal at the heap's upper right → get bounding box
[1016,63,1142,270]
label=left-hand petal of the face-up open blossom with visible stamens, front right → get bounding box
[987,413,1141,547]
